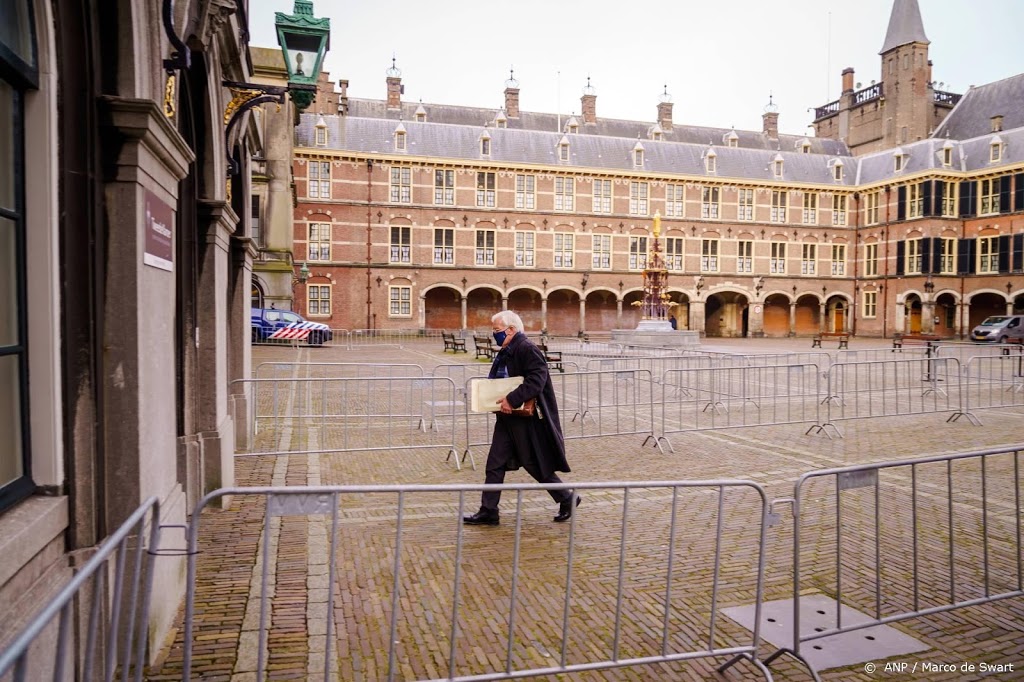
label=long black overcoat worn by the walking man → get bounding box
[488,332,570,476]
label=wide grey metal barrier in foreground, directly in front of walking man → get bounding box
[182,480,772,682]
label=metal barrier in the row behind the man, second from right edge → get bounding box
[807,357,970,438]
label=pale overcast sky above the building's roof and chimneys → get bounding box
[249,0,1024,134]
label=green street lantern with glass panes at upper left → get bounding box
[273,0,331,112]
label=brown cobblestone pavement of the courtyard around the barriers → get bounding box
[148,339,1024,681]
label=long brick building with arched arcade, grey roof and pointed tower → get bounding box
[254,0,1024,336]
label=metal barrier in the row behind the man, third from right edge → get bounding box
[655,364,824,452]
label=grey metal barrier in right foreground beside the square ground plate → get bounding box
[765,445,1024,680]
